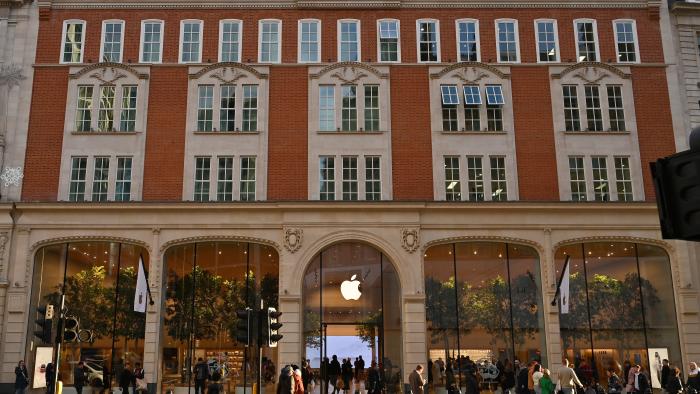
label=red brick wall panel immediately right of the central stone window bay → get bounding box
[391,67,433,200]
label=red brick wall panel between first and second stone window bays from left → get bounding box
[143,67,187,201]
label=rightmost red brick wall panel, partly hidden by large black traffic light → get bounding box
[632,67,676,201]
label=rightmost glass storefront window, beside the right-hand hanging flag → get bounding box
[556,242,682,388]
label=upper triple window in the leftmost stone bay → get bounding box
[75,85,138,132]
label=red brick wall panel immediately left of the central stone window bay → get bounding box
[267,67,309,200]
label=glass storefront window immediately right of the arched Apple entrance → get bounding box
[424,242,547,393]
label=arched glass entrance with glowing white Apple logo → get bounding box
[303,242,403,394]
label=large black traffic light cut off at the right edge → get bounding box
[651,146,700,241]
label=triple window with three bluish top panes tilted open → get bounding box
[440,84,505,131]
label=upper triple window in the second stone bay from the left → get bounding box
[196,84,258,131]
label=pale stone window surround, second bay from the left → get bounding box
[182,62,269,201]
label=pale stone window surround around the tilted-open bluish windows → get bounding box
[430,62,519,201]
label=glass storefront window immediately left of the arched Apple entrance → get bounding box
[161,242,279,393]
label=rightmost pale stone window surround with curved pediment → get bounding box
[549,62,645,201]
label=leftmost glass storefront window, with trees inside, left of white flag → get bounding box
[27,242,148,387]
